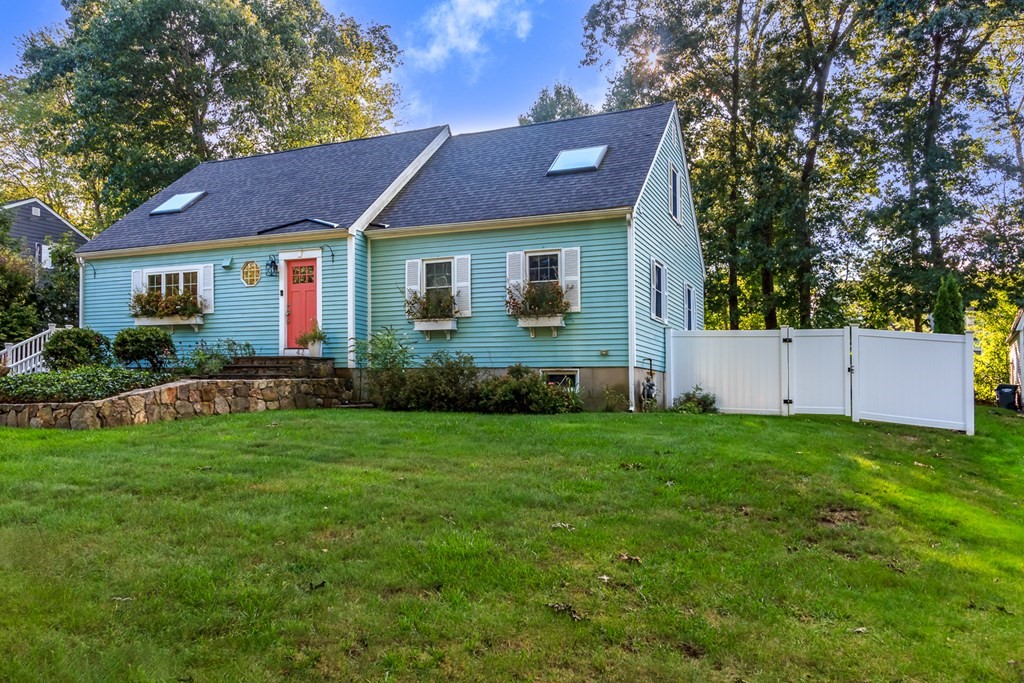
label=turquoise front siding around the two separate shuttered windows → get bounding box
[371,221,629,368]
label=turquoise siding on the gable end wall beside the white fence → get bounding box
[633,120,705,371]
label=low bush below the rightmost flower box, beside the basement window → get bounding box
[479,365,583,415]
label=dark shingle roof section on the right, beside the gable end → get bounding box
[370,102,674,231]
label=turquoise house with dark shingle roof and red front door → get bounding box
[78,103,705,404]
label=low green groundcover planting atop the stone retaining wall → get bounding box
[0,366,170,403]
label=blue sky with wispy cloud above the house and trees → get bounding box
[0,0,609,133]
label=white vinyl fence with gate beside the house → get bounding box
[666,327,974,434]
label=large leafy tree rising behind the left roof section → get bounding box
[23,0,397,220]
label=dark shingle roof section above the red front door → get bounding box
[79,126,444,253]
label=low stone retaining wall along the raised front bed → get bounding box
[0,378,352,429]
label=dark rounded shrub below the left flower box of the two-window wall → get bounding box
[398,351,480,413]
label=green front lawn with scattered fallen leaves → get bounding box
[0,409,1024,681]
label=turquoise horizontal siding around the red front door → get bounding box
[84,239,348,358]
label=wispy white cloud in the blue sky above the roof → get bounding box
[407,0,534,71]
